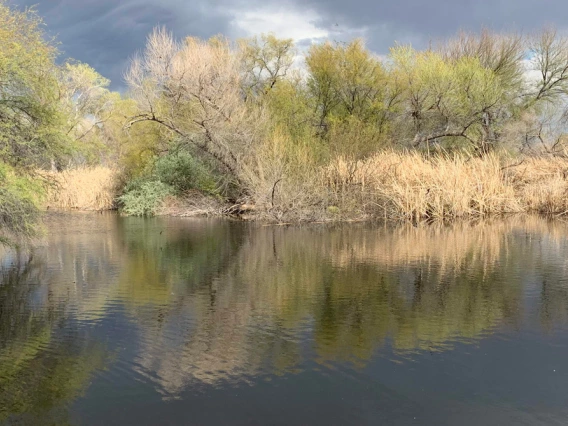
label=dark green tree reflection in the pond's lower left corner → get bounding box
[0,253,106,425]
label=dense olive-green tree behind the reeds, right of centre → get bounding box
[306,39,401,152]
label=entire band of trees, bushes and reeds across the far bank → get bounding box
[4,2,568,242]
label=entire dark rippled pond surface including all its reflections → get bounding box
[0,214,568,425]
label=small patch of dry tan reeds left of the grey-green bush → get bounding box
[46,166,119,210]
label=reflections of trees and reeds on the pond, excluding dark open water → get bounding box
[0,215,568,424]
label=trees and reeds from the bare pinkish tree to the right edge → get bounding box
[118,25,568,221]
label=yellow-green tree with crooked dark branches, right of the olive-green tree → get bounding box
[391,46,511,153]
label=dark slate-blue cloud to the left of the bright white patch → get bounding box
[12,0,234,89]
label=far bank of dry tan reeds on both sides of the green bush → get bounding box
[46,151,568,223]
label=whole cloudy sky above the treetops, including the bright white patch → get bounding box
[9,0,568,89]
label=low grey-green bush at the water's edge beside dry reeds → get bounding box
[118,179,175,216]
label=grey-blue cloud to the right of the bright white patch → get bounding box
[297,0,568,53]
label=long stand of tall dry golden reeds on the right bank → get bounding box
[324,152,568,221]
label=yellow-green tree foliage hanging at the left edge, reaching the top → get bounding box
[0,1,66,171]
